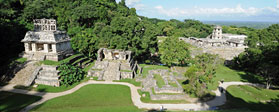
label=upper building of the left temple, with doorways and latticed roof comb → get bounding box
[21,19,73,61]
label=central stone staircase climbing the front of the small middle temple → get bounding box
[103,62,120,81]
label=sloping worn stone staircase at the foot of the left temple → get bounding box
[9,61,40,86]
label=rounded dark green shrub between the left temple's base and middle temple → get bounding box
[58,63,85,86]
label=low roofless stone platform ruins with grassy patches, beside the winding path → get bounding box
[139,69,198,102]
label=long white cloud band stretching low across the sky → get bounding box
[154,5,279,17]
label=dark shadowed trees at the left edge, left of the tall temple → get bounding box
[0,0,27,75]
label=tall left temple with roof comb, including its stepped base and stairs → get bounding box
[10,19,73,86]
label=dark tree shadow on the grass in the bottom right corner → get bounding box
[219,92,279,112]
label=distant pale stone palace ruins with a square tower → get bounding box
[179,26,247,60]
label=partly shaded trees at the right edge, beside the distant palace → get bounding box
[233,24,279,88]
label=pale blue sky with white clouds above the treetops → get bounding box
[116,0,279,22]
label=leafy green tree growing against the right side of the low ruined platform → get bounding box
[183,54,222,97]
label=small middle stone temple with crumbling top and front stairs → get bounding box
[88,48,139,81]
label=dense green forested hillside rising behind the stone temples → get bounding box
[0,0,279,79]
